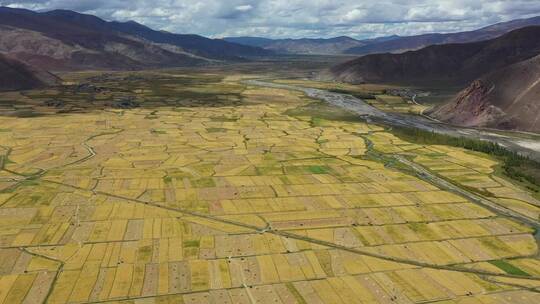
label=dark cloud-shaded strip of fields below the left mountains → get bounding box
[0,72,245,118]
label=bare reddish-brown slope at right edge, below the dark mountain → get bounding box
[428,55,540,132]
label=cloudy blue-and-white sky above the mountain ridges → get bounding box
[0,0,540,39]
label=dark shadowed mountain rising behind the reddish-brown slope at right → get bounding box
[322,26,540,85]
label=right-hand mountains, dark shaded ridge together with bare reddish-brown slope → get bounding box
[322,26,540,132]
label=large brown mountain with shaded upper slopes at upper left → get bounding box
[0,7,207,70]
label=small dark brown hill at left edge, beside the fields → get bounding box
[0,55,59,91]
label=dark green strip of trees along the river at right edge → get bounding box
[393,127,540,191]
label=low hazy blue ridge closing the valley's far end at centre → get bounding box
[224,36,388,55]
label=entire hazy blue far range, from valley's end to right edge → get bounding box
[224,17,540,55]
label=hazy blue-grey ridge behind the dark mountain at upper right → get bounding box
[345,16,540,55]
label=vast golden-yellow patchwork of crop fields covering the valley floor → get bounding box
[0,71,540,304]
